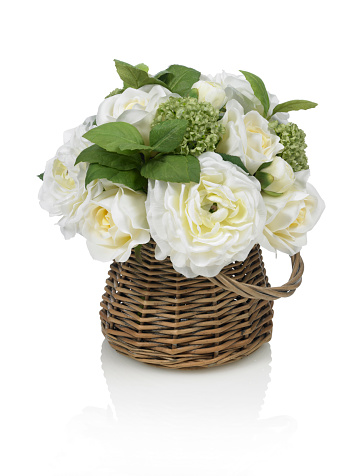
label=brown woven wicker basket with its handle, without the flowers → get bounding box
[100,241,303,369]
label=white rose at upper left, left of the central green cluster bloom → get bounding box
[97,84,180,144]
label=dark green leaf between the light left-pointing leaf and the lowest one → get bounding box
[75,144,142,170]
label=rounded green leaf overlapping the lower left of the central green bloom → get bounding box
[150,119,188,152]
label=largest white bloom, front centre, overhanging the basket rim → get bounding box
[146,152,265,278]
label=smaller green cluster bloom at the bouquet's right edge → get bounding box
[269,121,309,172]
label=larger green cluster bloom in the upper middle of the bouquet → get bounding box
[153,97,225,156]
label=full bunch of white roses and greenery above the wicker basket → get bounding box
[39,60,324,278]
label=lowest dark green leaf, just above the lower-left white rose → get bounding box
[85,164,147,190]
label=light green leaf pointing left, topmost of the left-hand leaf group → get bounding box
[83,122,149,152]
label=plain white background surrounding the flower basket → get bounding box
[0,0,362,476]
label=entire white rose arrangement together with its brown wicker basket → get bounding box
[39,61,324,368]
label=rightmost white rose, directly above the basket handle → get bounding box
[261,171,325,256]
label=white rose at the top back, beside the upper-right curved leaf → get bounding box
[201,71,289,124]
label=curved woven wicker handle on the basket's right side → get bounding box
[209,253,304,301]
